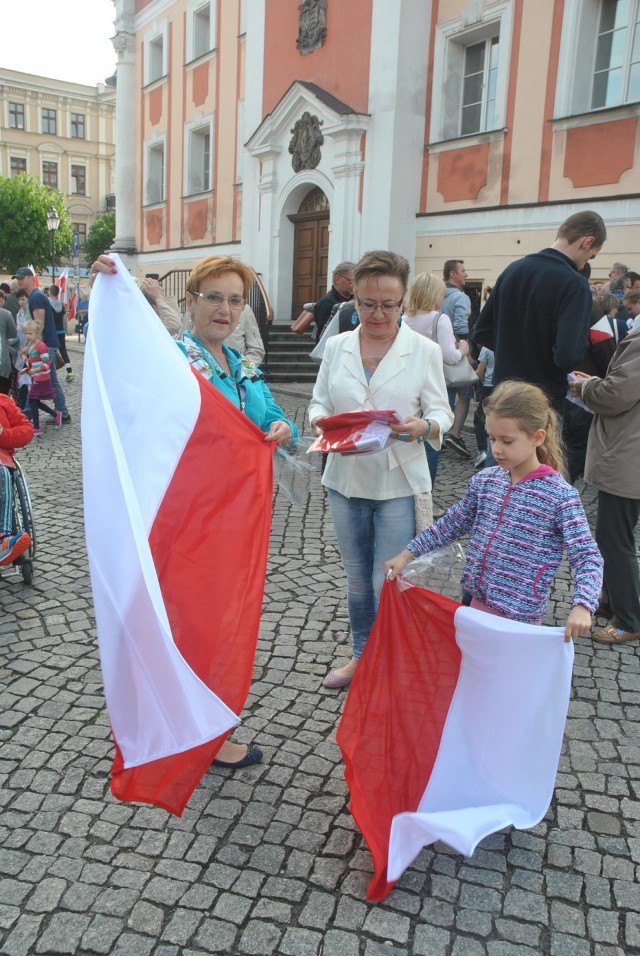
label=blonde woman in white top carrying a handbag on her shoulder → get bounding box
[404,272,477,485]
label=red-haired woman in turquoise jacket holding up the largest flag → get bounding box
[91,255,296,769]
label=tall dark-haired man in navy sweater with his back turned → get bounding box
[472,211,607,411]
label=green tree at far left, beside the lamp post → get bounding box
[0,174,73,275]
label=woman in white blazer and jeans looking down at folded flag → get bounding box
[309,251,453,688]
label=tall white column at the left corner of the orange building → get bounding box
[111,30,138,254]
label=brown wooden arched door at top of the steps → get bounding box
[289,187,329,319]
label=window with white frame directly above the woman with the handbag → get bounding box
[460,37,499,136]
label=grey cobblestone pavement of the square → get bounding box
[0,343,640,956]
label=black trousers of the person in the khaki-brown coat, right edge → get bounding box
[596,491,640,632]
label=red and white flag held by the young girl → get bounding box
[337,579,573,900]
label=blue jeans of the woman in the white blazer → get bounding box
[328,488,416,660]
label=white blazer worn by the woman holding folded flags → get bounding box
[309,324,453,500]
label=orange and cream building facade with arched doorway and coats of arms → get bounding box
[114,0,640,322]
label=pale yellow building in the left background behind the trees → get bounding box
[0,69,115,260]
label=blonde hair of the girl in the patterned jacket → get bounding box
[482,381,566,477]
